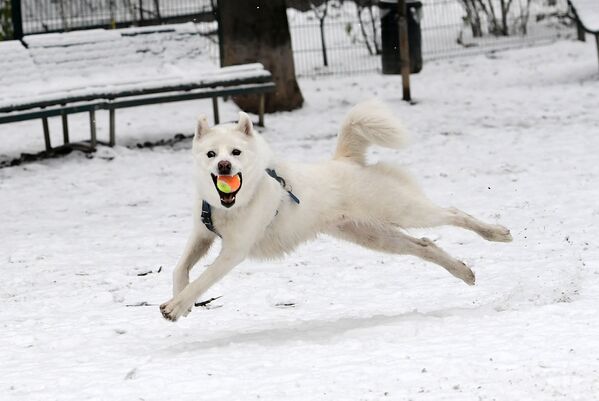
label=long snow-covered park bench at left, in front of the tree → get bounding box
[0,23,275,151]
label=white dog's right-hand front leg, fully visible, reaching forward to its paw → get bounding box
[160,243,247,322]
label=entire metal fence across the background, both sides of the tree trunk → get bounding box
[4,0,574,76]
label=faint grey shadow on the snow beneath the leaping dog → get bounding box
[165,307,488,353]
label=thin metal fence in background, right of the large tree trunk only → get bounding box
[288,0,574,76]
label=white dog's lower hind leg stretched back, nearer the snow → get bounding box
[327,222,475,285]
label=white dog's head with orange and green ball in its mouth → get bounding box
[192,112,271,208]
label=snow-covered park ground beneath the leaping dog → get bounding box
[0,41,599,401]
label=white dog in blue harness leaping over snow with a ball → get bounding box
[160,101,512,321]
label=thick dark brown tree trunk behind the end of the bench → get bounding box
[218,0,304,113]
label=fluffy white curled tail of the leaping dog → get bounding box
[333,99,407,165]
